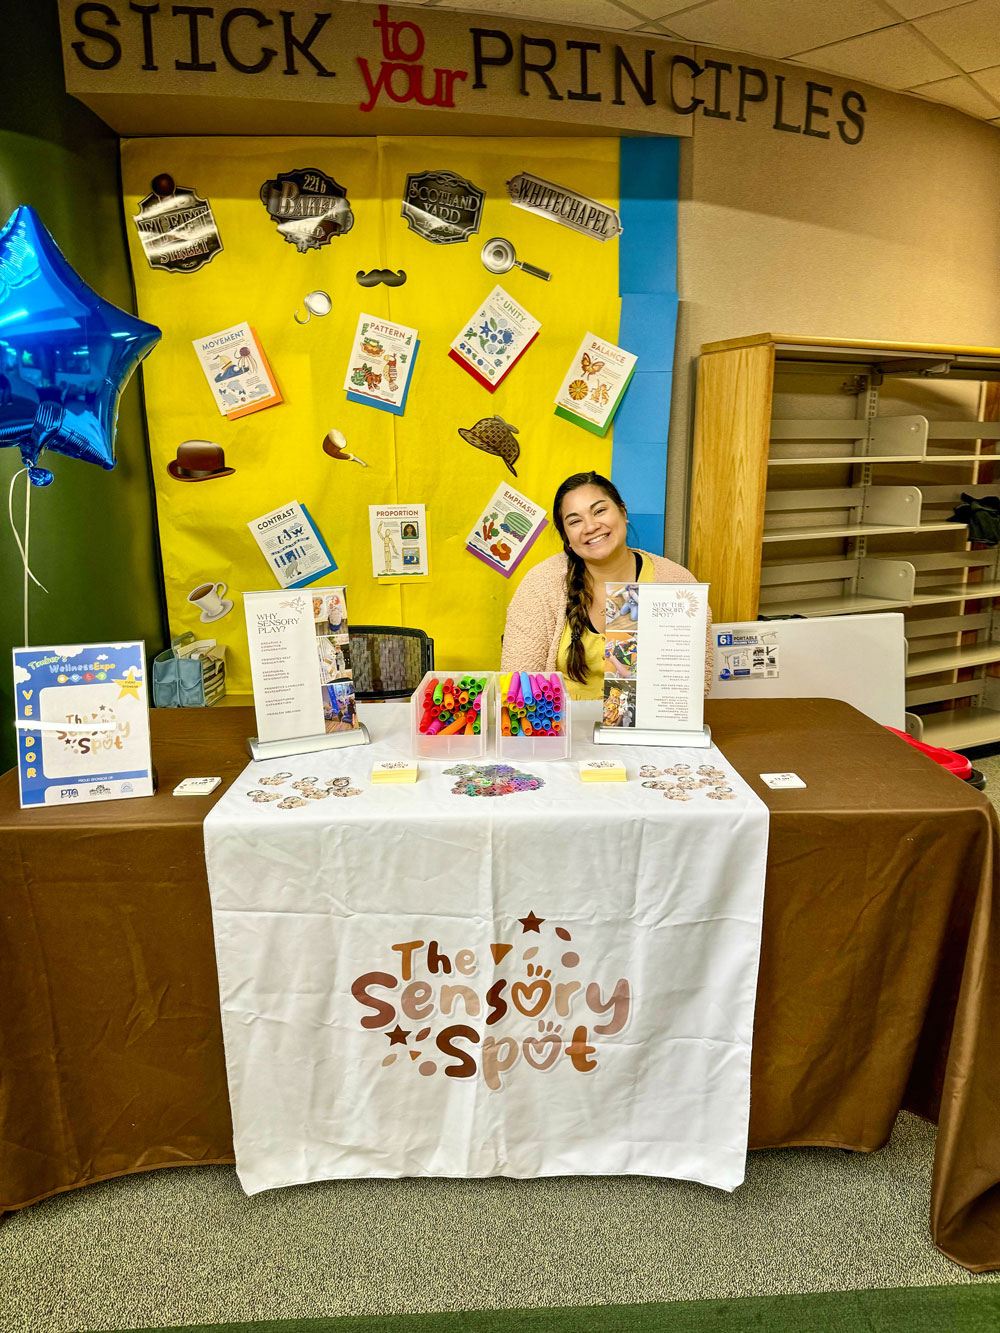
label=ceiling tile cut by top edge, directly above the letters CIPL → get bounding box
[664,0,891,60]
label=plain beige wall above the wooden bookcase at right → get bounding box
[667,48,1000,557]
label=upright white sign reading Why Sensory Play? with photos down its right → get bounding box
[243,588,371,760]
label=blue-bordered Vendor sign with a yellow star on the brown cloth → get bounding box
[13,641,153,808]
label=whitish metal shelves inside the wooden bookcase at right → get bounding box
[759,352,1000,748]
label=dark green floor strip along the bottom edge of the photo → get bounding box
[81,1281,1000,1333]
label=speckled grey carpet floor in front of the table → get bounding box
[0,1114,1000,1333]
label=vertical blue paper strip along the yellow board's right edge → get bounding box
[611,139,680,555]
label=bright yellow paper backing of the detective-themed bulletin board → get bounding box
[121,137,620,693]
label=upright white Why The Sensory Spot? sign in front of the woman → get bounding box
[593,583,712,749]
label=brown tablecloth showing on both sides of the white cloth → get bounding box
[0,700,1000,1270]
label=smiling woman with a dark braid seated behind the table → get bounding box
[500,472,712,698]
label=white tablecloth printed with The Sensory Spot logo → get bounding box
[205,704,768,1193]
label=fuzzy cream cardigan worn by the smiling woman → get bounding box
[500,551,713,694]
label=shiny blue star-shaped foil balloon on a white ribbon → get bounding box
[0,205,160,487]
